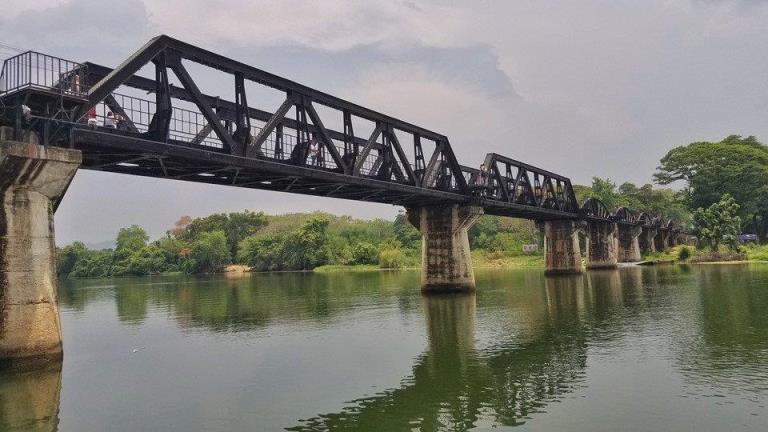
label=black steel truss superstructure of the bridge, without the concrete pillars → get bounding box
[0,35,684,233]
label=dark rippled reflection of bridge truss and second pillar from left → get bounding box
[288,287,586,431]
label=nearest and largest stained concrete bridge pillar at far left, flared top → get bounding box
[0,140,82,368]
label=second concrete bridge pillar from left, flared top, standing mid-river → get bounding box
[407,205,483,292]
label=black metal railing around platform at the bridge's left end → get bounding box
[0,51,88,97]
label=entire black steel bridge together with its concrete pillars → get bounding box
[0,36,683,368]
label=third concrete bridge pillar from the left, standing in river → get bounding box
[539,220,582,275]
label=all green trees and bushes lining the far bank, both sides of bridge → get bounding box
[57,135,768,277]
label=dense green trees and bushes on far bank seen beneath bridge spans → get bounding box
[58,211,538,277]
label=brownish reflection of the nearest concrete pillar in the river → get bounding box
[0,366,61,432]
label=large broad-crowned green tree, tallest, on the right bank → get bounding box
[654,135,768,241]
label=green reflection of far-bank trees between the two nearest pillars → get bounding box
[60,271,419,331]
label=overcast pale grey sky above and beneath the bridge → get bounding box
[0,0,768,244]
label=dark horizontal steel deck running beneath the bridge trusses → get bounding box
[73,126,576,220]
